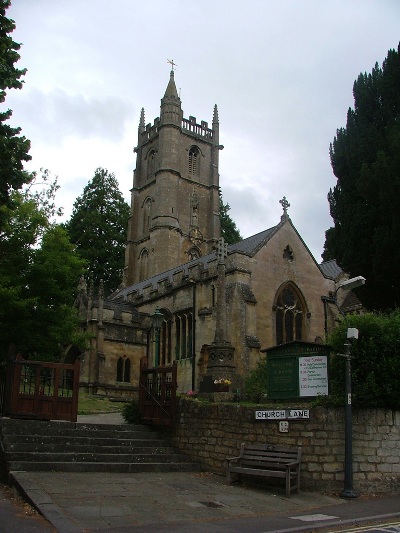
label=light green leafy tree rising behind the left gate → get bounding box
[0,172,85,360]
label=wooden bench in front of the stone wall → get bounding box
[226,443,301,497]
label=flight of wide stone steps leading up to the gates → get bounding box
[0,418,200,472]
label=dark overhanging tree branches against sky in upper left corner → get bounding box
[0,0,31,228]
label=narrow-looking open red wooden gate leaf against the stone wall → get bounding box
[139,357,177,426]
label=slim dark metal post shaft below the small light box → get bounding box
[341,342,358,498]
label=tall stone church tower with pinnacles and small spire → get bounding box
[124,70,223,286]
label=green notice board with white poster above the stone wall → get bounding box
[262,341,329,399]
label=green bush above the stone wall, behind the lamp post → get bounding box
[328,309,400,409]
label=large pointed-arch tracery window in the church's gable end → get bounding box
[275,283,305,345]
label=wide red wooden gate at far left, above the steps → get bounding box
[3,355,80,422]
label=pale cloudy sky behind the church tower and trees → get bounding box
[2,0,400,262]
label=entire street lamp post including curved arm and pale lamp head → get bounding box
[335,276,365,498]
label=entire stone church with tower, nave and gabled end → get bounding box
[77,69,359,397]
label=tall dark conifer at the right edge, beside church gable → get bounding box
[323,45,400,309]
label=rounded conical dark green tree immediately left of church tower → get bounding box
[65,168,130,291]
